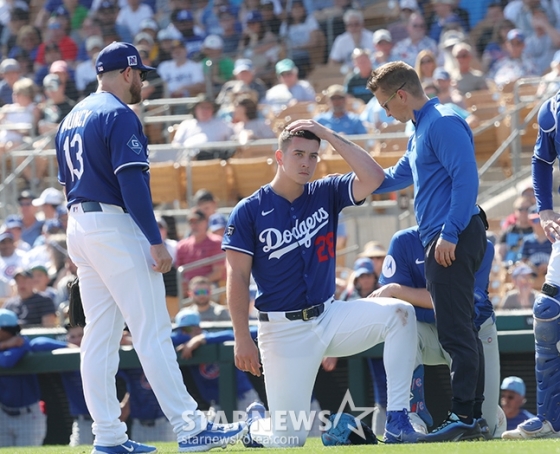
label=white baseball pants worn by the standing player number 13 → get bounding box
[67,204,206,446]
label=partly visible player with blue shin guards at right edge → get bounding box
[502,87,560,439]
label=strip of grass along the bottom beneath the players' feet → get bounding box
[0,438,560,454]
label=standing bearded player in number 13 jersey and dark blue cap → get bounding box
[55,42,246,454]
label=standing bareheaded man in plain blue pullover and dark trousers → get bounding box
[368,61,486,441]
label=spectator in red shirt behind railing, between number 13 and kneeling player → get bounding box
[176,209,225,294]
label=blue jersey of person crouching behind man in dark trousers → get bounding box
[379,226,494,329]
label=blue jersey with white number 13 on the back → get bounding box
[55,92,149,207]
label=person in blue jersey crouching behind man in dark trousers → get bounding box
[373,227,500,438]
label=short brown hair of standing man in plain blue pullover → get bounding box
[366,61,423,97]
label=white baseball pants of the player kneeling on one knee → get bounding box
[251,298,417,447]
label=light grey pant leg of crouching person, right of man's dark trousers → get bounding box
[478,317,500,434]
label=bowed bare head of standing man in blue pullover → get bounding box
[367,61,426,123]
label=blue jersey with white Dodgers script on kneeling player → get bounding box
[222,173,356,312]
